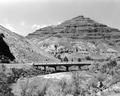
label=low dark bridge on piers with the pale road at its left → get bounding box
[0,61,94,72]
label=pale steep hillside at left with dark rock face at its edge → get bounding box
[0,26,57,63]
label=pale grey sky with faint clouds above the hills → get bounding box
[0,0,120,36]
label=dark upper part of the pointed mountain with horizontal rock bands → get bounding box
[27,16,120,44]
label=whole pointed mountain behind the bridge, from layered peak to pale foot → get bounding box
[27,16,120,61]
